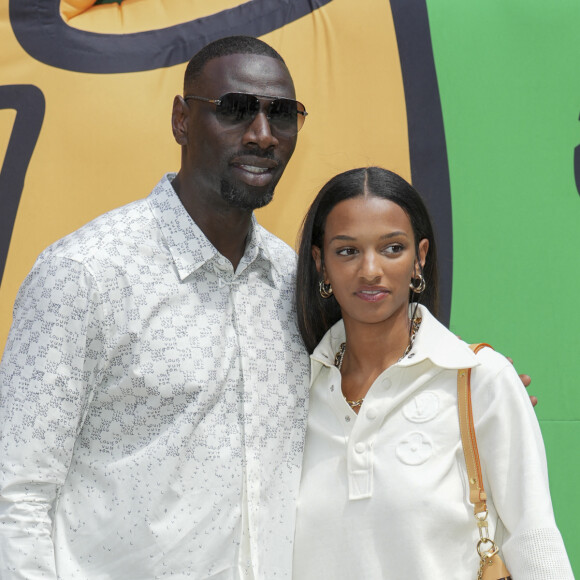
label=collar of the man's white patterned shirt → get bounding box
[148,173,280,280]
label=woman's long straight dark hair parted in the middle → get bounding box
[296,167,439,352]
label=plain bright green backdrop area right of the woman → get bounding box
[427,0,580,574]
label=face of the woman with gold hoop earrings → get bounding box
[312,196,429,324]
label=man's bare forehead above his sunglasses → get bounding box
[194,54,294,97]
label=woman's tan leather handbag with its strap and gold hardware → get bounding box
[457,342,511,580]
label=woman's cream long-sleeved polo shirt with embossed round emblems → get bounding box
[293,307,573,580]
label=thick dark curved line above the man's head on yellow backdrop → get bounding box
[10,0,332,74]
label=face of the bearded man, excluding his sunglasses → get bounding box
[182,54,296,210]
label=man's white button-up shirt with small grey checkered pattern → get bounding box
[0,174,309,580]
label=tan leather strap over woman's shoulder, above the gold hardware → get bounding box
[457,342,492,514]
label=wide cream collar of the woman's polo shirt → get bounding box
[310,305,479,369]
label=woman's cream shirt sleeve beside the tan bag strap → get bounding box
[471,349,574,580]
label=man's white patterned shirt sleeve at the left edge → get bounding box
[0,255,103,580]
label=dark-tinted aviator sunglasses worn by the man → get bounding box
[183,93,308,137]
